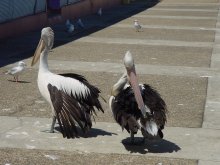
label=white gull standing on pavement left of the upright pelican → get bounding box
[5,61,27,82]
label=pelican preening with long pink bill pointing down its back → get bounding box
[109,51,167,143]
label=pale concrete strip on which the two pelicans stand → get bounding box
[0,117,220,161]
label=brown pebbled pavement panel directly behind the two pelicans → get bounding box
[0,66,207,127]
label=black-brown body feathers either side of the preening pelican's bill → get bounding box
[112,84,167,137]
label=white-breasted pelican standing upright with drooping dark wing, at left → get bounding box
[31,27,104,138]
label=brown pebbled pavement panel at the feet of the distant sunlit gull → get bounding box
[90,27,215,42]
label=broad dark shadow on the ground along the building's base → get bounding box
[0,0,160,67]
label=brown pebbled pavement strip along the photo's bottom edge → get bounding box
[0,148,198,165]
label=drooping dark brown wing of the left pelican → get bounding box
[48,84,92,138]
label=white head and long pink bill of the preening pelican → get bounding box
[124,51,147,117]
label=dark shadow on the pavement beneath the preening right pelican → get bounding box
[122,137,181,154]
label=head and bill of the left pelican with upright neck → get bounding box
[31,27,54,66]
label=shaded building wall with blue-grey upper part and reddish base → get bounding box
[0,0,121,39]
